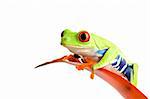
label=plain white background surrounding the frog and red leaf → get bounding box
[0,0,150,99]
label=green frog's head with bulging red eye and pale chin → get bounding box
[61,29,96,56]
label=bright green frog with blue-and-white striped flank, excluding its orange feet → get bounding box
[61,29,138,86]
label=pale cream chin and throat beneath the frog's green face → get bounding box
[64,45,101,61]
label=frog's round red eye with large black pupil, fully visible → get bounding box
[78,31,90,42]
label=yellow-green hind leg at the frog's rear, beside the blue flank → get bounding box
[131,63,138,86]
